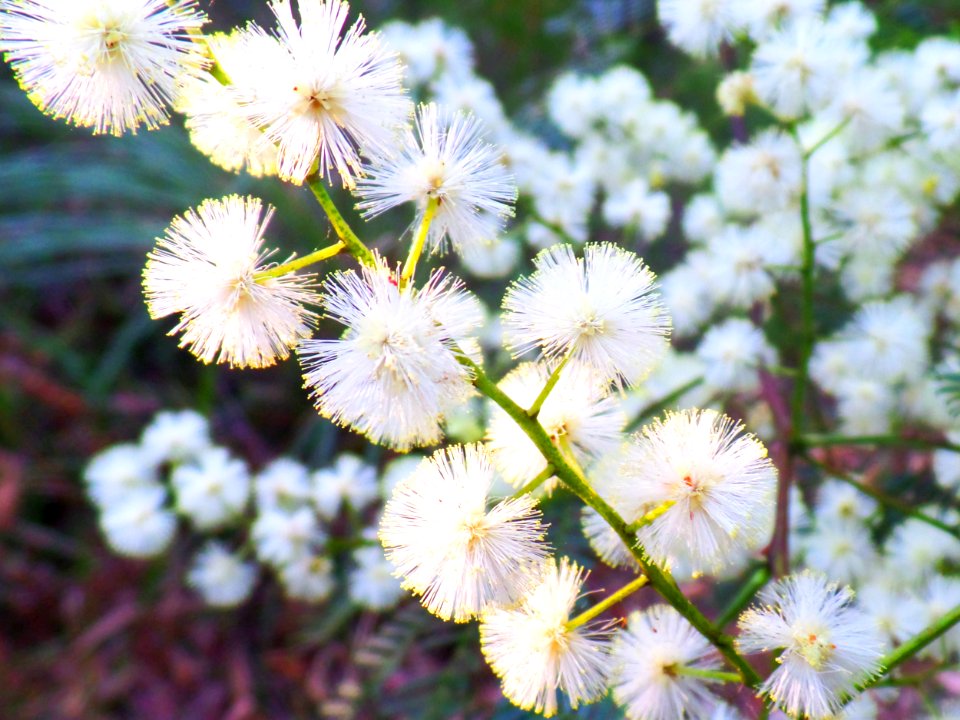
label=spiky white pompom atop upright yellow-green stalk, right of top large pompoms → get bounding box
[356,103,517,251]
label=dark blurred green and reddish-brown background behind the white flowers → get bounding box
[0,0,960,720]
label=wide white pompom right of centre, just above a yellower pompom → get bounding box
[502,243,670,385]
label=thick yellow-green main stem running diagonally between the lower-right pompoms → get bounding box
[459,353,762,689]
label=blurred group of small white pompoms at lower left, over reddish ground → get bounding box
[84,410,400,610]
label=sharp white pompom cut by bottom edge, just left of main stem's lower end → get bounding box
[610,605,720,720]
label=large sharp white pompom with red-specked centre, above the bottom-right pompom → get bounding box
[620,410,777,570]
